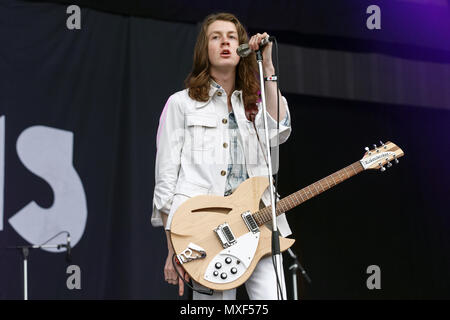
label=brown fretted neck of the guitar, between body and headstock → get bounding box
[253,161,364,226]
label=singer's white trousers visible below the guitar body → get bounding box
[193,256,286,300]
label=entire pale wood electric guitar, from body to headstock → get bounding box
[170,142,404,290]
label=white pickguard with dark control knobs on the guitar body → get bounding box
[204,232,260,283]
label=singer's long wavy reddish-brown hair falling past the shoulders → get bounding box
[185,13,259,121]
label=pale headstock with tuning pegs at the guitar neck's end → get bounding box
[360,141,404,172]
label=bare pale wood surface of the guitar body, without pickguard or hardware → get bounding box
[171,177,295,290]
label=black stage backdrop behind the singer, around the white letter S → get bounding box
[0,0,450,299]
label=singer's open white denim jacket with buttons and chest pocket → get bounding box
[151,84,291,237]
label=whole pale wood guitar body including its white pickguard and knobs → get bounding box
[171,177,295,290]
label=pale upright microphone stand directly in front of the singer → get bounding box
[256,49,283,298]
